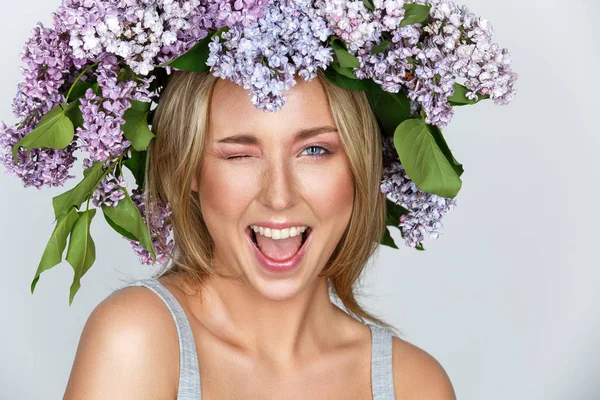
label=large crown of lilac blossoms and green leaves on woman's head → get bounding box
[0,0,517,304]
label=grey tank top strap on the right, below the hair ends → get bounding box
[367,323,396,400]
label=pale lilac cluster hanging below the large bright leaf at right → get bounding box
[380,137,456,247]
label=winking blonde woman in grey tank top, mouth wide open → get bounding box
[65,72,455,400]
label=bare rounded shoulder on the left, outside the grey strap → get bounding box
[64,286,179,400]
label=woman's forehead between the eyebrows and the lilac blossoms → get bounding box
[209,77,335,140]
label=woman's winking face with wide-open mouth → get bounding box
[192,78,354,300]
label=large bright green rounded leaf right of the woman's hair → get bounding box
[394,119,462,198]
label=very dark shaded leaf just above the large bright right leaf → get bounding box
[367,80,410,137]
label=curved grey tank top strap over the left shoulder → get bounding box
[115,279,202,400]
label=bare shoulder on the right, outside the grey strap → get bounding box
[392,336,456,400]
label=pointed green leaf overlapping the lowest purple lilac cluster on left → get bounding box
[102,191,156,260]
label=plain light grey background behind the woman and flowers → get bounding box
[0,0,600,400]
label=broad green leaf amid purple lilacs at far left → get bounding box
[12,104,75,165]
